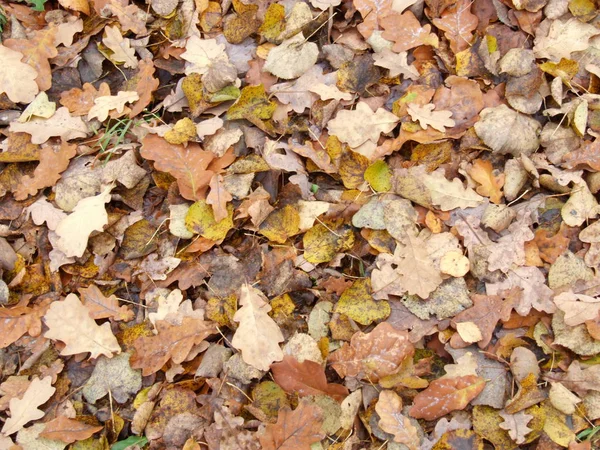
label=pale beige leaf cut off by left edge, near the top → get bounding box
[0,44,39,103]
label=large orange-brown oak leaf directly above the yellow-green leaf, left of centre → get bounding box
[140,135,214,200]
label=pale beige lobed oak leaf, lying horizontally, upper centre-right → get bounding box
[327,102,400,148]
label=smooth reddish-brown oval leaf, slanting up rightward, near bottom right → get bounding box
[409,375,485,420]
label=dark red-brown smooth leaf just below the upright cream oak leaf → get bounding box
[271,355,348,401]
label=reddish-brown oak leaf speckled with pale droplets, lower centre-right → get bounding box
[329,322,415,382]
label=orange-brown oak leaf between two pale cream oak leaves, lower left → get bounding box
[131,317,216,376]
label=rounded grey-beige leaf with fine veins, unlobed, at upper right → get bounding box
[475,104,541,156]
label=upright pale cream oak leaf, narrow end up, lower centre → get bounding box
[231,284,284,370]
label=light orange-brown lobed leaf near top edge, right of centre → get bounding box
[379,11,439,53]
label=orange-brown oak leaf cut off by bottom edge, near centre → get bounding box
[259,402,325,450]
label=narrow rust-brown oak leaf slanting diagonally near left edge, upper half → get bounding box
[14,142,77,200]
